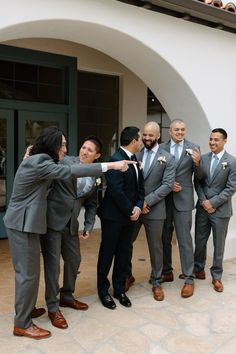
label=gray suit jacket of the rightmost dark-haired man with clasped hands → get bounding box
[195,152,236,218]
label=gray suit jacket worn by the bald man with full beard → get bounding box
[137,146,175,220]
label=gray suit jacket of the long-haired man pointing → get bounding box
[4,154,102,234]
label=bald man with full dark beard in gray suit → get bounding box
[126,122,175,301]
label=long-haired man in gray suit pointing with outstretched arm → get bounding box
[4,127,132,339]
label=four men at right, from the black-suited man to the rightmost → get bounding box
[97,119,236,309]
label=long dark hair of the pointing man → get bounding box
[30,126,65,162]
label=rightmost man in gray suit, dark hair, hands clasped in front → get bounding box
[194,128,236,292]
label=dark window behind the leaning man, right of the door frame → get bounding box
[78,71,119,161]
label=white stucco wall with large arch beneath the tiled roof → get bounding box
[0,0,236,257]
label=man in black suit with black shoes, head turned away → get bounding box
[97,127,144,309]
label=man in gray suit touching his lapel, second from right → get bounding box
[161,119,200,298]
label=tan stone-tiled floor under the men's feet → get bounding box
[0,227,236,354]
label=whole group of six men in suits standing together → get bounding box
[5,119,236,339]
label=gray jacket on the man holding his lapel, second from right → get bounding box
[161,139,200,211]
